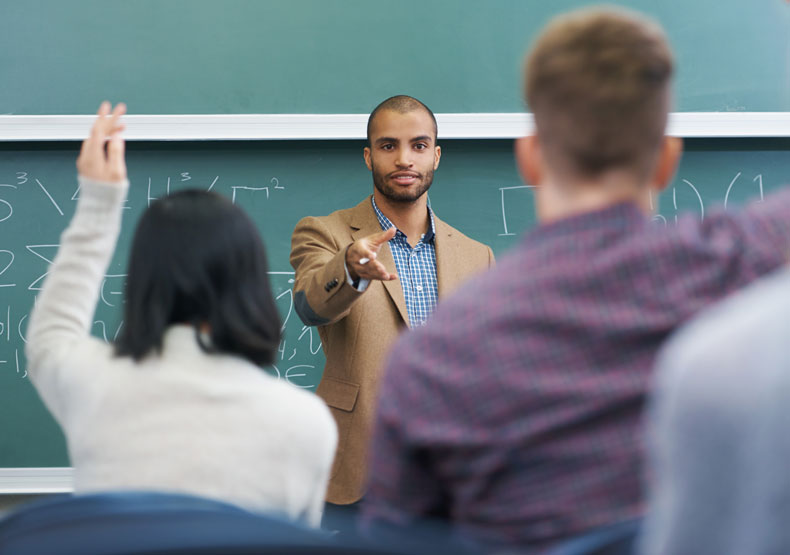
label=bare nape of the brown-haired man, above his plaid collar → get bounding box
[535,174,654,224]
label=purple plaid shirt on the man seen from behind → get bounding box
[362,190,790,550]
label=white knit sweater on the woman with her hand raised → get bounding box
[27,178,337,526]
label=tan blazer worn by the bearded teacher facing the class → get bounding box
[291,197,494,505]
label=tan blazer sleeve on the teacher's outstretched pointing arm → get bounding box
[291,217,363,326]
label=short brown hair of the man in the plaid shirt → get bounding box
[525,9,673,178]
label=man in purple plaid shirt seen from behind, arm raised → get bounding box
[363,9,790,551]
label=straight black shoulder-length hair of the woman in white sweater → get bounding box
[115,190,280,370]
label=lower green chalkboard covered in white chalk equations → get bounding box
[0,139,790,467]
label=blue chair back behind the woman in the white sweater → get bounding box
[0,492,406,555]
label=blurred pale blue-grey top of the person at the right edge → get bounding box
[643,264,790,555]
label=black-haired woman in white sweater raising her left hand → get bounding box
[27,103,337,526]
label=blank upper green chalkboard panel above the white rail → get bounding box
[0,0,790,114]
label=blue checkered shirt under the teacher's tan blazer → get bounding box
[370,197,439,328]
